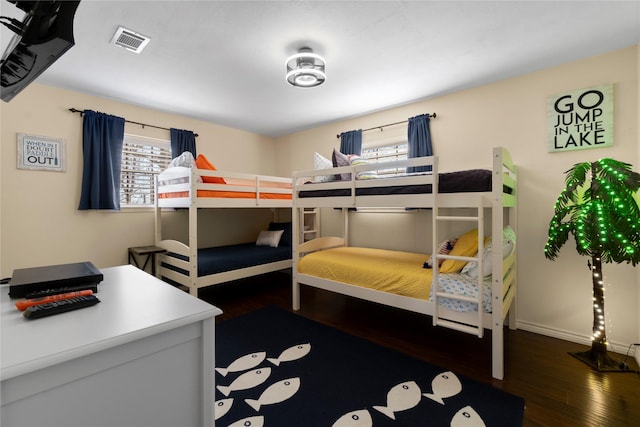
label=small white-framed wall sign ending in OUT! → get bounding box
[18,133,66,172]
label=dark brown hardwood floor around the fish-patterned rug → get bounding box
[199,271,640,427]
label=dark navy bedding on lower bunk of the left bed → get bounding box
[163,243,291,276]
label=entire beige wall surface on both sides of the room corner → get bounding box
[0,46,640,350]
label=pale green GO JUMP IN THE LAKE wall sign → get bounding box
[547,83,613,153]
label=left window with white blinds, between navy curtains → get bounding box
[120,135,171,207]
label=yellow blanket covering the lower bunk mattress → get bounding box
[298,247,432,300]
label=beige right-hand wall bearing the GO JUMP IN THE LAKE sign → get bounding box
[276,46,640,350]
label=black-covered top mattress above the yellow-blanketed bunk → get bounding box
[298,169,491,198]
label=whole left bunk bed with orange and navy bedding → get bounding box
[155,162,293,296]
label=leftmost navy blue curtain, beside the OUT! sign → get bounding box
[78,110,125,210]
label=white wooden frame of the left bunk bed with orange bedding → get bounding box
[155,168,293,296]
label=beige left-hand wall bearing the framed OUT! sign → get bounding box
[0,84,275,277]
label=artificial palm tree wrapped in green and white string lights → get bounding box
[544,159,640,371]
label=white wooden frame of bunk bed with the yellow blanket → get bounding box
[292,147,517,379]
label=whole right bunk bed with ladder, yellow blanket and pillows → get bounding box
[292,147,517,379]
